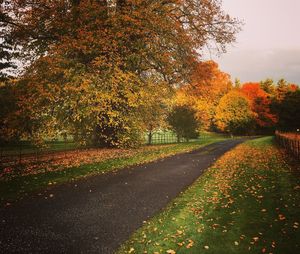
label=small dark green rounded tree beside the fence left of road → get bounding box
[167,106,199,142]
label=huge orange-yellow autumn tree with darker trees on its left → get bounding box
[0,0,240,146]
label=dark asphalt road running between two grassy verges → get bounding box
[0,140,244,253]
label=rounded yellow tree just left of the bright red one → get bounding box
[215,90,255,134]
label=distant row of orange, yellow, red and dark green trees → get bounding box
[177,72,300,134]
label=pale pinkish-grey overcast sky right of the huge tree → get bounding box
[212,0,300,84]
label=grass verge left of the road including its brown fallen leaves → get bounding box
[0,135,225,205]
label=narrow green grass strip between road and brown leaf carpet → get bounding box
[0,135,225,204]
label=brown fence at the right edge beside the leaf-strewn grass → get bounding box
[275,131,300,160]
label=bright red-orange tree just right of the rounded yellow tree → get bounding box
[240,83,278,129]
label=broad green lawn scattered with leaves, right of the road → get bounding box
[119,137,300,254]
